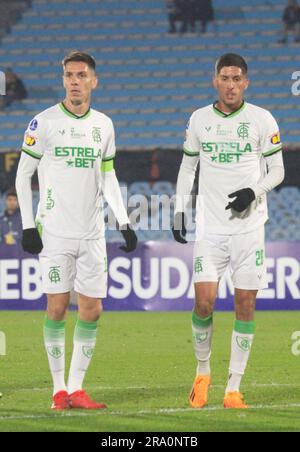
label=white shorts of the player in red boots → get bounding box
[39,230,108,298]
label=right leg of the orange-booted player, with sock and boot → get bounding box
[224,289,257,409]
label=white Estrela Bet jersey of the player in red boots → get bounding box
[22,103,116,239]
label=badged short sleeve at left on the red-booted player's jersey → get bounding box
[22,117,46,160]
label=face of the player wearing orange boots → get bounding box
[213,66,249,109]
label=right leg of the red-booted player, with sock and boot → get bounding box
[68,295,106,410]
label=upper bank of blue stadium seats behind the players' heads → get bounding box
[0,0,300,151]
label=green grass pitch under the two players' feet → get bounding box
[0,312,300,432]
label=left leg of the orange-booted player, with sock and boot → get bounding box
[189,282,218,408]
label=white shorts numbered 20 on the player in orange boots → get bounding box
[193,226,268,290]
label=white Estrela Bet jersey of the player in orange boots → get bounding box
[184,102,282,234]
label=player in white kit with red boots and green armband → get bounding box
[16,52,137,410]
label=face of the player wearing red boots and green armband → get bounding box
[63,61,98,105]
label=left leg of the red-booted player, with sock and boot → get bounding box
[44,292,70,410]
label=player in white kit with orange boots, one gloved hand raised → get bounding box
[173,54,284,409]
